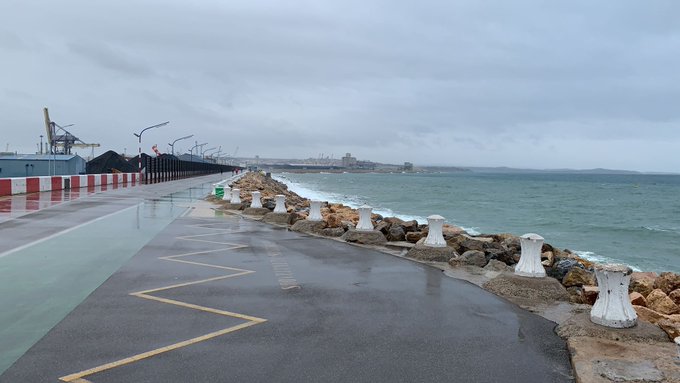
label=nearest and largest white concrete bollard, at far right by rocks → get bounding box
[590,264,637,328]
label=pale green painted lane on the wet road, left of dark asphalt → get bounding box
[0,183,220,374]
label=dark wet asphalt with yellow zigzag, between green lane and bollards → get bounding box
[0,212,572,383]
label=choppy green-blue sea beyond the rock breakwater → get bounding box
[275,172,680,272]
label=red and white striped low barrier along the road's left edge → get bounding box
[0,173,140,196]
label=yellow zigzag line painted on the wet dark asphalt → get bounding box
[59,218,267,383]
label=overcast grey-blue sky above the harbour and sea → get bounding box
[0,0,680,172]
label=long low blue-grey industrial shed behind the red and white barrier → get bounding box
[0,154,86,178]
